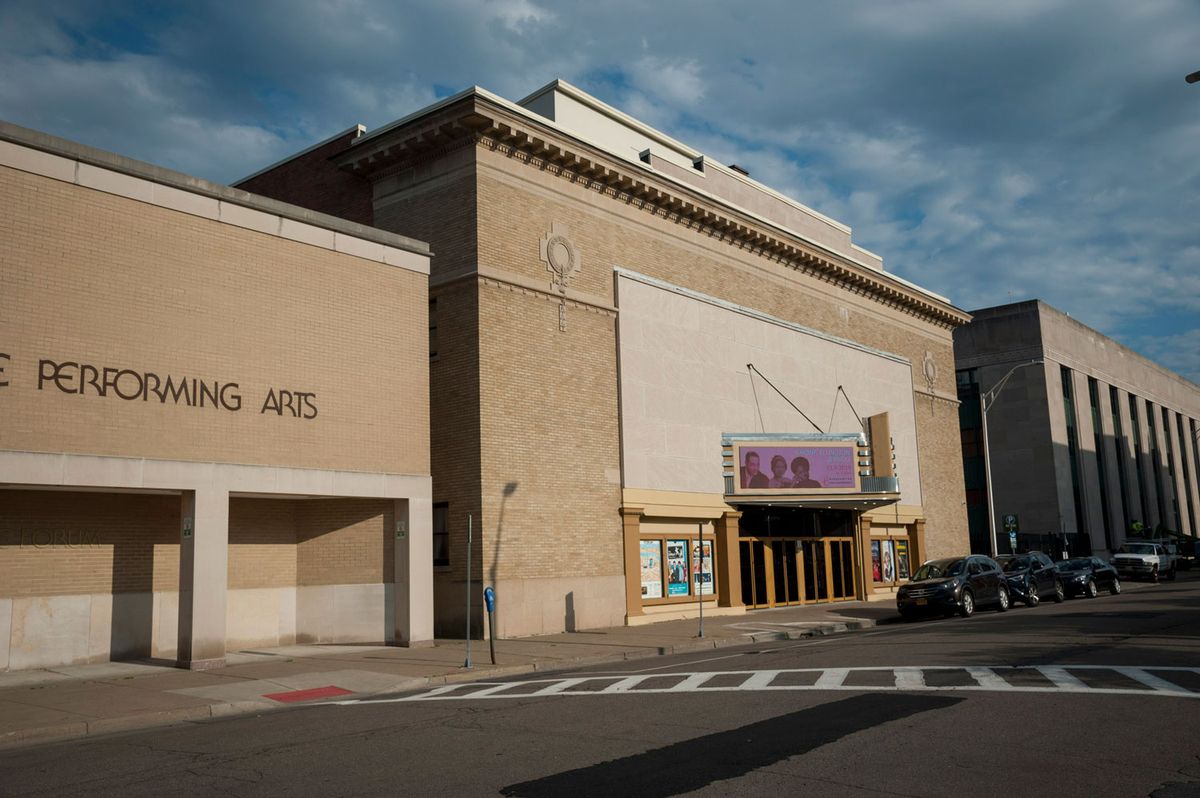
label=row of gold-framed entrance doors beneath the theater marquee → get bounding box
[739,538,858,608]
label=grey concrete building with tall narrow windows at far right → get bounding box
[954,301,1200,554]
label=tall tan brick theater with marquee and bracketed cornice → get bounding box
[239,76,968,635]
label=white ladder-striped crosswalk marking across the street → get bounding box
[331,665,1200,706]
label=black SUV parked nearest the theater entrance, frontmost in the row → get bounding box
[896,554,1012,618]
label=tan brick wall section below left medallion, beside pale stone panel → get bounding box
[480,286,624,581]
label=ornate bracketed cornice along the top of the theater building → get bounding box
[332,90,971,329]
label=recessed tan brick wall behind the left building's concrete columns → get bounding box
[0,491,395,598]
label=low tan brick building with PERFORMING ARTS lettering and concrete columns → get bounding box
[0,125,433,670]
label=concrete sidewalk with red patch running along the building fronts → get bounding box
[0,601,899,749]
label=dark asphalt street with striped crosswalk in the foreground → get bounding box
[0,576,1200,798]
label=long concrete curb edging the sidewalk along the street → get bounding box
[0,618,876,751]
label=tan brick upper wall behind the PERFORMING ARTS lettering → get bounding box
[0,162,428,474]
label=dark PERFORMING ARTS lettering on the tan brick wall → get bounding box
[0,353,318,421]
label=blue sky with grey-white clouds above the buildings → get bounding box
[7,0,1200,382]
